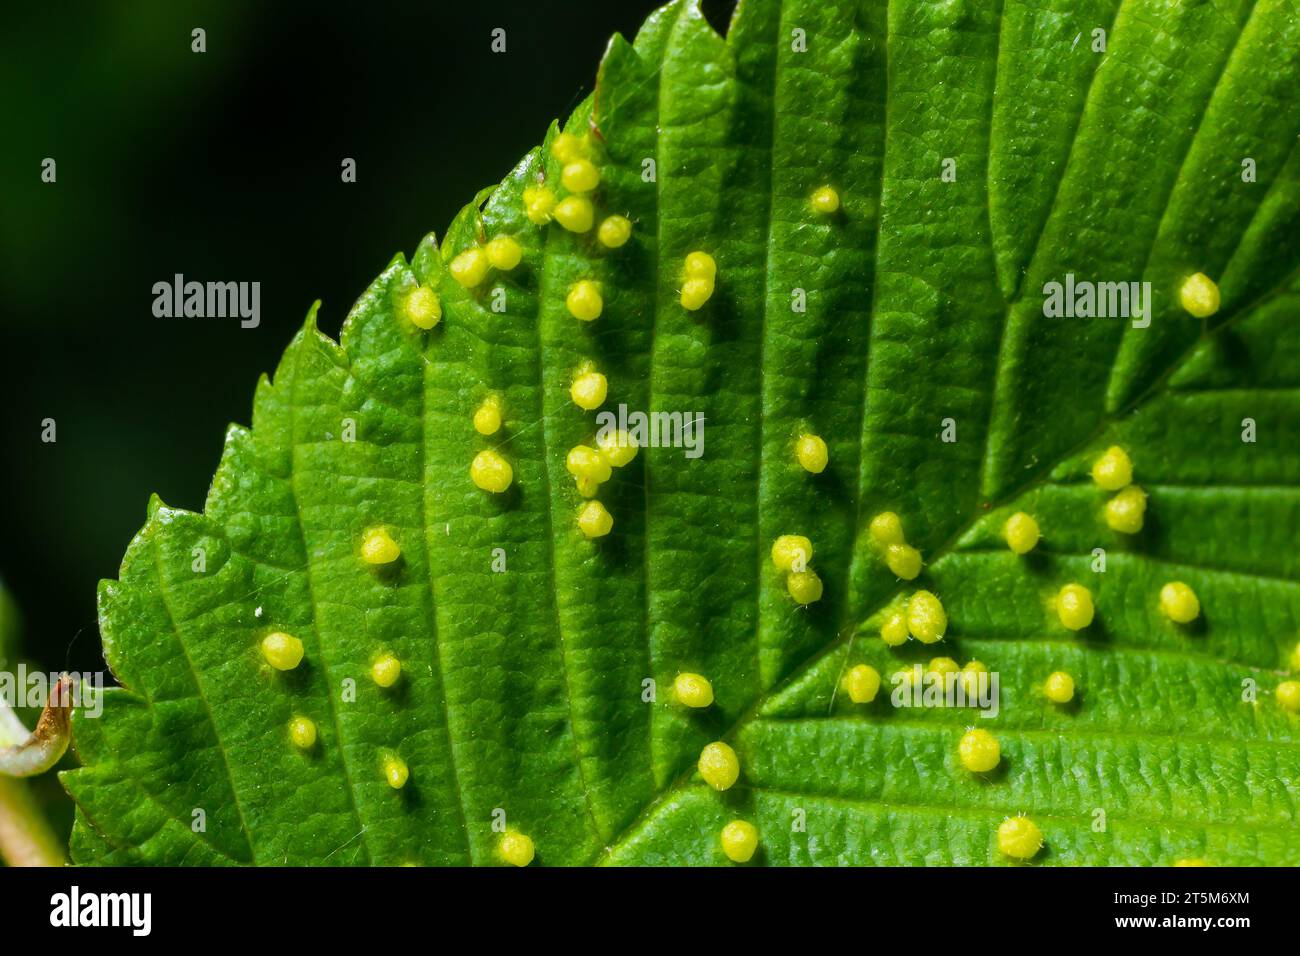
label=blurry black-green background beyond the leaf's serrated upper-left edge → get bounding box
[0,0,754,686]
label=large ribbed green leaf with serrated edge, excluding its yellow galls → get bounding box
[64,0,1300,864]
